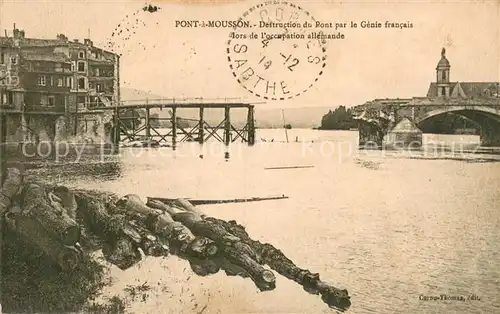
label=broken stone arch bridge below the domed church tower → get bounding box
[353,98,500,147]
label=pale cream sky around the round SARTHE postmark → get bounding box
[0,0,500,108]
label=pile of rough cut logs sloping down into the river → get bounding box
[0,168,351,310]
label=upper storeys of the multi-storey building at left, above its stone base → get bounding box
[0,25,119,140]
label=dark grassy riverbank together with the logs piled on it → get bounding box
[0,166,351,312]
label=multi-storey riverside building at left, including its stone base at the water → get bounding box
[0,26,119,142]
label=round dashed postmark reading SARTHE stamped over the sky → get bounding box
[226,0,326,100]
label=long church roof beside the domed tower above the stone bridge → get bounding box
[427,82,500,98]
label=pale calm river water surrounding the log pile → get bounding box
[27,130,500,313]
